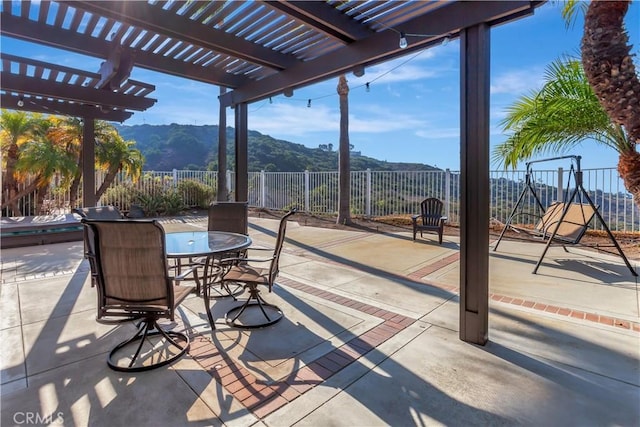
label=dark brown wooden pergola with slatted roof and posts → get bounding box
[0,0,542,344]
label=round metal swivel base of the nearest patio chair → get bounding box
[107,320,190,372]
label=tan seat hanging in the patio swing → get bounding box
[535,202,595,244]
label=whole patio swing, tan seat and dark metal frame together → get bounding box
[493,155,638,277]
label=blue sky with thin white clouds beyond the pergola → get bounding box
[1,1,640,170]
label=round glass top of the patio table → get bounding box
[165,231,252,258]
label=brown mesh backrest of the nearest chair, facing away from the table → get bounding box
[82,218,174,320]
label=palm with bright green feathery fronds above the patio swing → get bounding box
[492,58,640,207]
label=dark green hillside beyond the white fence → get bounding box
[116,123,437,172]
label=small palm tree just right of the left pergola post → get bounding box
[96,127,144,200]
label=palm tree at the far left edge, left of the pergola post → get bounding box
[0,110,39,216]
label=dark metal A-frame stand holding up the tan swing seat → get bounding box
[493,156,638,276]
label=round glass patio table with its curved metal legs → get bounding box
[165,231,252,329]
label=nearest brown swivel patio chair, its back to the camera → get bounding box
[81,218,192,372]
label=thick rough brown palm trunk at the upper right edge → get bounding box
[580,0,640,207]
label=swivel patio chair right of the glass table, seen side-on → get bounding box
[215,209,296,329]
